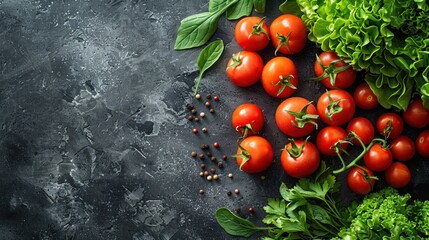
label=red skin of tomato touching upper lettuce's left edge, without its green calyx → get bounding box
[314,52,356,89]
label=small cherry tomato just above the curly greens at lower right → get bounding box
[384,162,411,188]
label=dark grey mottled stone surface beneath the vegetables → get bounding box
[0,0,429,240]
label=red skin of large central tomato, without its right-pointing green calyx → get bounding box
[275,97,317,138]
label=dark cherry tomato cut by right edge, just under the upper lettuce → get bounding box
[402,98,429,128]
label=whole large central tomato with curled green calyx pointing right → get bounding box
[276,97,318,138]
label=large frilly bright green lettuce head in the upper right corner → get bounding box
[280,0,429,110]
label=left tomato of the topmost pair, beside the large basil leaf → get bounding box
[234,17,270,51]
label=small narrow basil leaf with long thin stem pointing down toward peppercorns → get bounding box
[195,39,224,94]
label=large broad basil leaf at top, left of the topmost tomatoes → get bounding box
[174,0,238,50]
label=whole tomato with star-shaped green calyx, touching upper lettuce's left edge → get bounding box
[314,52,356,89]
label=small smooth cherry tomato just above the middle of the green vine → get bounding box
[347,117,375,146]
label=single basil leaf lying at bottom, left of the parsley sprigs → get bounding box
[215,208,266,237]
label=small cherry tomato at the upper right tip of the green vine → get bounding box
[376,112,404,139]
